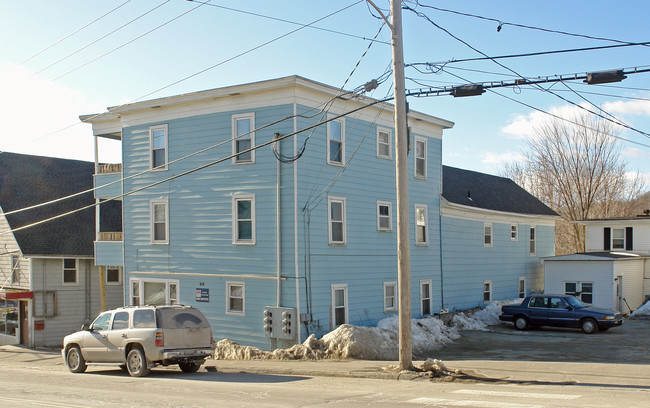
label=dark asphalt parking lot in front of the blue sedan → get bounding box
[422,318,650,364]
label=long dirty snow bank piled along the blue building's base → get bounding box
[215,300,521,362]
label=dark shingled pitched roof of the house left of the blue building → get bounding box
[0,152,121,256]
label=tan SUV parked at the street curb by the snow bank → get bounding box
[61,305,213,377]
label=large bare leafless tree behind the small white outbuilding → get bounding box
[502,113,644,255]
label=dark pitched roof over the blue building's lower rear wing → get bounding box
[442,166,558,216]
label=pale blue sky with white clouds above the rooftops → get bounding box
[0,0,650,185]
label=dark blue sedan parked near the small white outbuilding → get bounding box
[499,295,623,334]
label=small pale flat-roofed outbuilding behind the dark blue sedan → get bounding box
[542,252,650,314]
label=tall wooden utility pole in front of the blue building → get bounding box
[366,0,413,370]
